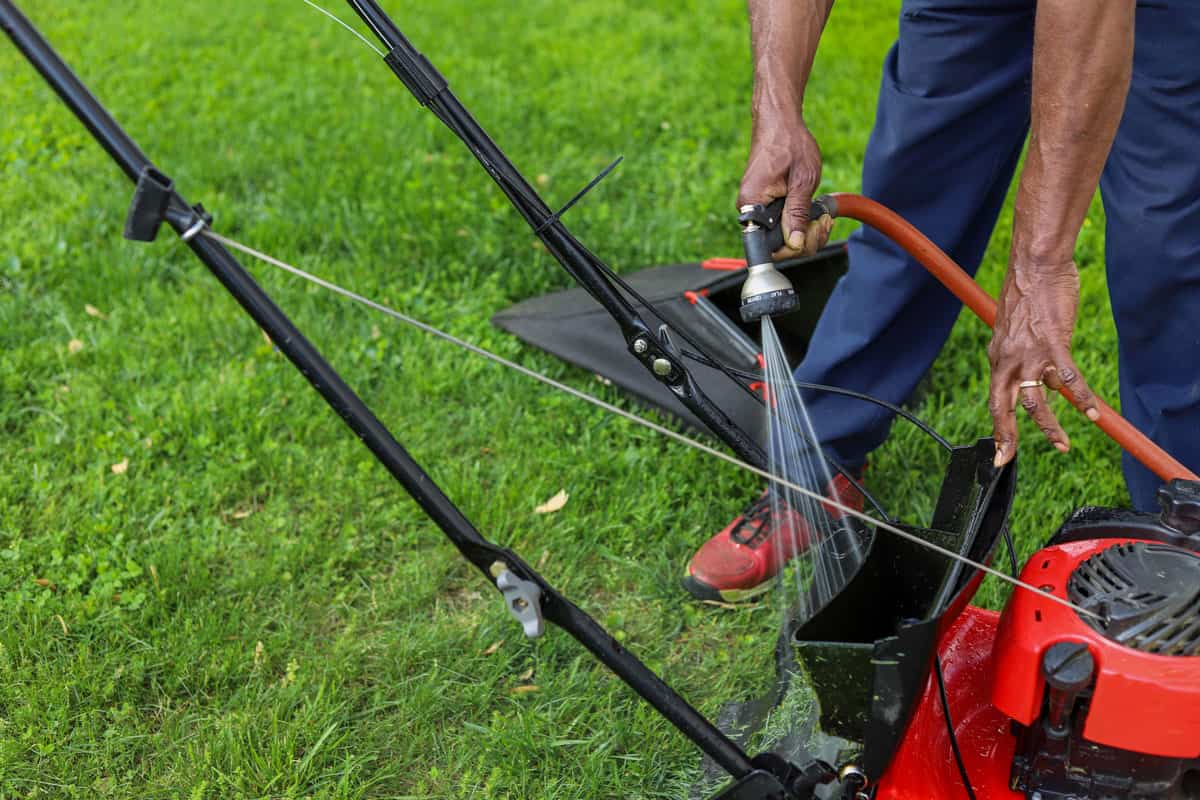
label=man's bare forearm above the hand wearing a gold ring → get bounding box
[1013,0,1134,269]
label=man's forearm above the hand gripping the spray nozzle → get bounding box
[746,0,833,124]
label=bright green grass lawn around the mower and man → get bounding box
[0,0,1126,799]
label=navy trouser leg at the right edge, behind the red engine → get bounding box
[1099,0,1200,510]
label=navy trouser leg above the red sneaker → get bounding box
[796,0,1034,464]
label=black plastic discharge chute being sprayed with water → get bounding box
[781,439,1016,781]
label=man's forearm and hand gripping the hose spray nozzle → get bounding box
[738,0,833,258]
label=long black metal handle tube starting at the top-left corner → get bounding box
[0,0,754,778]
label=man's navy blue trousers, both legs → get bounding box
[796,0,1200,509]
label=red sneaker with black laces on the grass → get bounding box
[683,474,863,603]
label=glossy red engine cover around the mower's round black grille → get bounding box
[991,539,1200,758]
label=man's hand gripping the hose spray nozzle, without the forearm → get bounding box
[738,108,833,258]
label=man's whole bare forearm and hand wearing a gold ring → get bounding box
[988,0,1128,467]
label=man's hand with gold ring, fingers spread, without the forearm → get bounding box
[988,261,1099,467]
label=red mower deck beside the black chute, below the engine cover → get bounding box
[876,606,1024,800]
